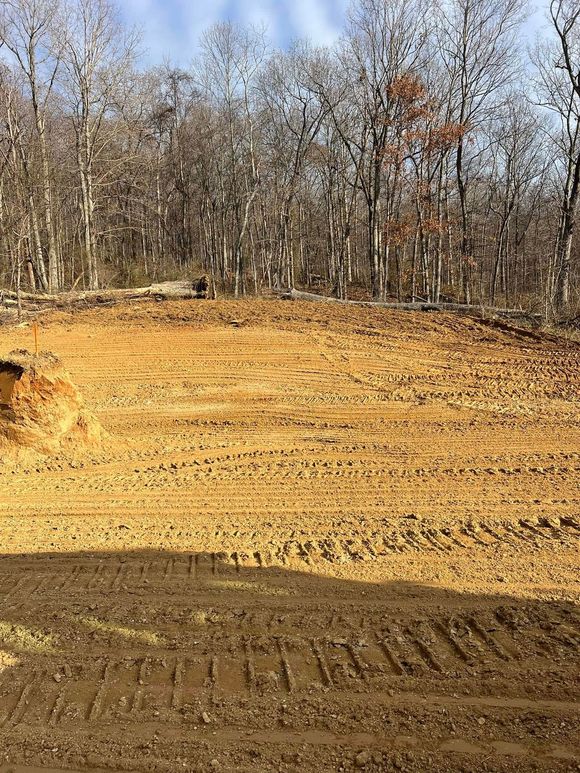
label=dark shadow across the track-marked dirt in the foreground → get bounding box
[0,551,580,771]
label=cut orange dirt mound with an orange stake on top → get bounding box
[0,349,102,453]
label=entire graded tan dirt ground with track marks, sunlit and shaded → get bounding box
[0,301,580,773]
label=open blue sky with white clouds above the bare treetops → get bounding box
[119,0,547,66]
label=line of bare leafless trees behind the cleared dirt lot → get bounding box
[0,0,580,314]
